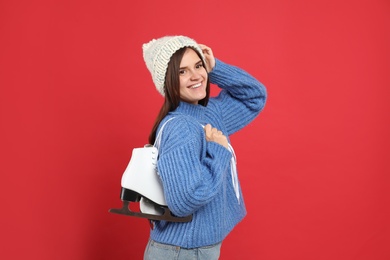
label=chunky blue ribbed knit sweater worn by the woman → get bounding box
[151,59,266,248]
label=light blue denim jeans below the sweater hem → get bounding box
[144,239,222,260]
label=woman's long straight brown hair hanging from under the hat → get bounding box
[149,47,210,144]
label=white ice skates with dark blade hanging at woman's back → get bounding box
[109,146,192,222]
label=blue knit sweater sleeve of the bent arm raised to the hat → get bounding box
[209,59,267,135]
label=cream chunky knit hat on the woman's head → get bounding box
[142,36,205,96]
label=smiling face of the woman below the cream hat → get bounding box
[179,48,208,104]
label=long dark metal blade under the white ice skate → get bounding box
[108,201,192,222]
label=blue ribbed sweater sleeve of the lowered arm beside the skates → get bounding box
[158,118,231,217]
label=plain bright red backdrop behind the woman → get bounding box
[0,0,390,260]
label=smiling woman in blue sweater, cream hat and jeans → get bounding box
[143,36,266,260]
